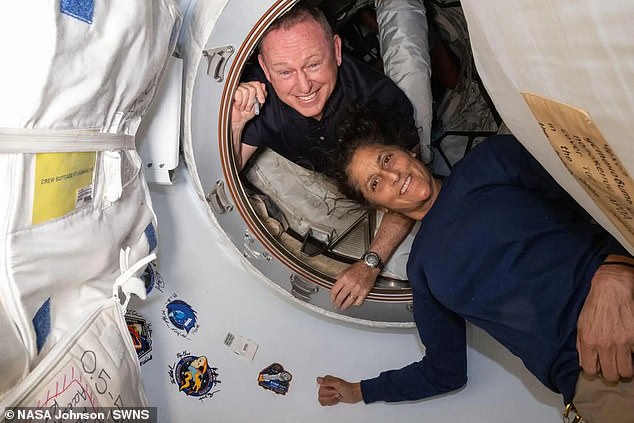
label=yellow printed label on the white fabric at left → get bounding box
[32,152,97,225]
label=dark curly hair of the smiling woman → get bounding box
[328,103,418,206]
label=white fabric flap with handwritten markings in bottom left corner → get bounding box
[0,299,149,412]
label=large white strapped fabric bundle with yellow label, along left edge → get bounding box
[0,0,180,406]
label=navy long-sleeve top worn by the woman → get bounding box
[361,136,628,403]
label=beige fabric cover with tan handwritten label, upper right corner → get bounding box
[462,0,634,253]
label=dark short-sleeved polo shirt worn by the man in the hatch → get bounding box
[242,55,418,177]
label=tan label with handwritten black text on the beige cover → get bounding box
[522,93,634,245]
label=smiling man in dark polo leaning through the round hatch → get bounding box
[231,5,418,309]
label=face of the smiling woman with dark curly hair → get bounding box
[347,145,440,220]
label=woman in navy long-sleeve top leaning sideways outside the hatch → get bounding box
[318,128,634,423]
